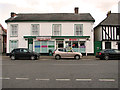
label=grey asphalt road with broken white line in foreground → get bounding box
[0,57,118,88]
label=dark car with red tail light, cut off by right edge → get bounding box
[96,49,120,60]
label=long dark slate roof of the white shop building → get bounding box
[5,13,95,23]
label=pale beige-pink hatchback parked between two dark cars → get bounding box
[53,48,82,60]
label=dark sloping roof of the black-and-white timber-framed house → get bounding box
[97,13,120,27]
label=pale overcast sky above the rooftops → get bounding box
[0,0,120,28]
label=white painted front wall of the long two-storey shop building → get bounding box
[7,22,94,53]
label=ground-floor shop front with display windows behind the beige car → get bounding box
[23,36,90,54]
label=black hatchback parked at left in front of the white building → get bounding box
[10,48,40,60]
